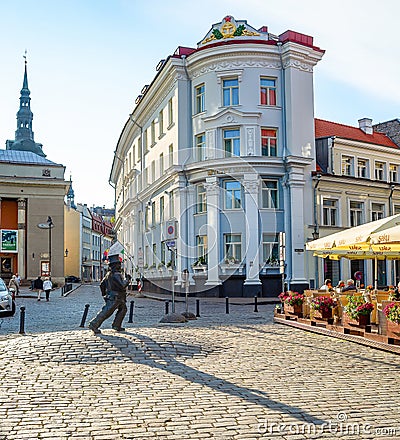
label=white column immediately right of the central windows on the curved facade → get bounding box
[242,174,261,296]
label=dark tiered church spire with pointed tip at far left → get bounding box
[6,51,46,157]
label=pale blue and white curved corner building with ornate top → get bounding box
[110,16,324,296]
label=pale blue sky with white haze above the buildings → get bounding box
[0,0,400,207]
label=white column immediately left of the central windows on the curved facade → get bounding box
[204,176,222,286]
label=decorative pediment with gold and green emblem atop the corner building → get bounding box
[198,15,262,47]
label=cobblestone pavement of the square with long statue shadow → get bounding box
[0,286,400,440]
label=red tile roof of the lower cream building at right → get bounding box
[315,118,399,149]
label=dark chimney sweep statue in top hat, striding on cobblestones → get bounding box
[89,254,131,334]
